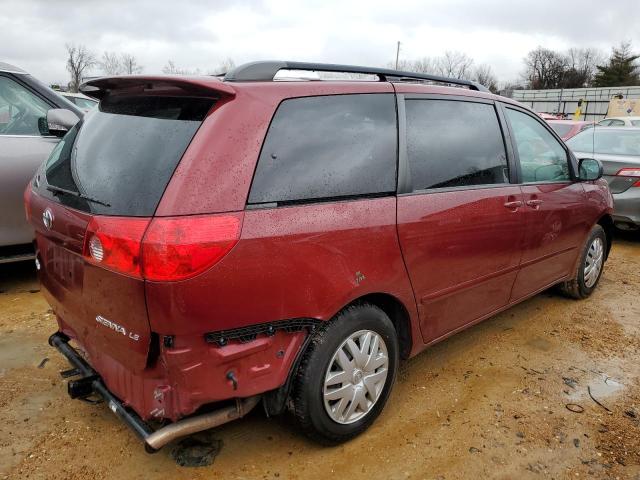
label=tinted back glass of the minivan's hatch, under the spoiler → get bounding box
[45,96,214,216]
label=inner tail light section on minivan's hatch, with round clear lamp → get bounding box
[84,217,150,278]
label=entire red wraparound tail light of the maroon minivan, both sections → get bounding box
[84,214,242,281]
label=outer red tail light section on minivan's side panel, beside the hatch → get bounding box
[142,214,241,281]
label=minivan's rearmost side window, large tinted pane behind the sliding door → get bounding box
[249,94,397,204]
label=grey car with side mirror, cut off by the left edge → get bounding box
[0,62,82,263]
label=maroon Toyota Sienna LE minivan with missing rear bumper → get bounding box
[25,62,612,451]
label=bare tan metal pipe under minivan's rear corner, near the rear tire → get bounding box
[145,395,261,452]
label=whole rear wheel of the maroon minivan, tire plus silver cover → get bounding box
[292,304,399,445]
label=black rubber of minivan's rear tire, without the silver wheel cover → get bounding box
[292,303,399,445]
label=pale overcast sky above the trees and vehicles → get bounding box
[0,0,640,83]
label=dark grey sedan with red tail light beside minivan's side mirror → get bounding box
[567,127,640,230]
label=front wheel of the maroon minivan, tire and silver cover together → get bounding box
[559,225,607,299]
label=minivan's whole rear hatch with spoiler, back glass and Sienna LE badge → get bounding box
[27,79,225,370]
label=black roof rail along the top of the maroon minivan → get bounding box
[224,60,489,92]
